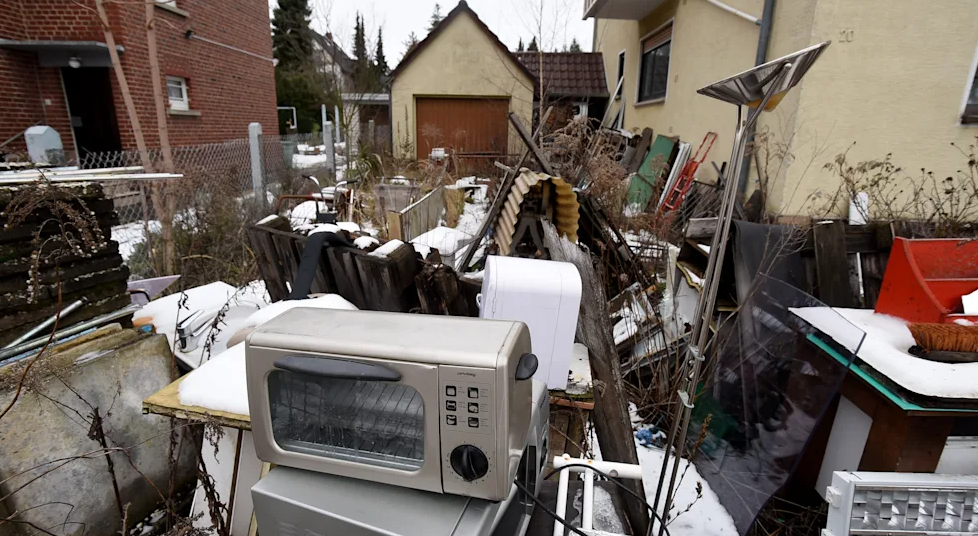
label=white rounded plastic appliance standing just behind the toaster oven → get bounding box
[479,256,581,389]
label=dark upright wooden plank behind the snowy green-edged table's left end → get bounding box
[813,221,856,307]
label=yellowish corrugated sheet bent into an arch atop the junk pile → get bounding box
[493,170,581,255]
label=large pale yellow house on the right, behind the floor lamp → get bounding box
[584,0,978,216]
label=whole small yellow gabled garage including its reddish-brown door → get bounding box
[391,0,534,159]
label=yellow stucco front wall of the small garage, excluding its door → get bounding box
[391,12,533,158]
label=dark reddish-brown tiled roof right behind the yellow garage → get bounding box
[515,52,609,97]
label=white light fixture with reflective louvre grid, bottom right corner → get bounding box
[822,471,978,536]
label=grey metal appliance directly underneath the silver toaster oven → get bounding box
[251,380,550,536]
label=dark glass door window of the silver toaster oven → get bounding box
[268,371,424,471]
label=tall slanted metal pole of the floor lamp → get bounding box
[652,63,791,536]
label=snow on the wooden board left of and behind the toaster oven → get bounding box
[179,294,357,415]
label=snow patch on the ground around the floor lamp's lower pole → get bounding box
[588,403,738,536]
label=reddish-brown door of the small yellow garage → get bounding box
[415,97,509,160]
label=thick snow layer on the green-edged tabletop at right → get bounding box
[789,307,978,400]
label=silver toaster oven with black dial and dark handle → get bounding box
[245,308,537,501]
